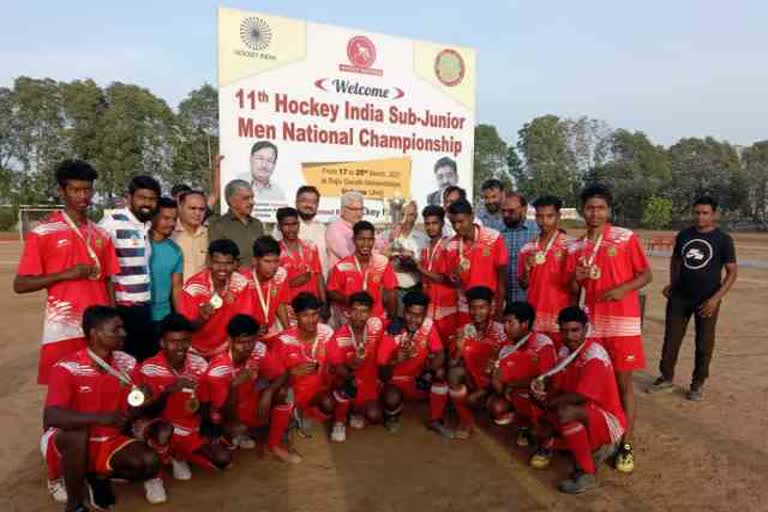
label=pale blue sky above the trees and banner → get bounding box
[0,0,768,145]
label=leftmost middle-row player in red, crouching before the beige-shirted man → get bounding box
[179,239,253,360]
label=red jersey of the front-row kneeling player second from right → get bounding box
[496,332,558,383]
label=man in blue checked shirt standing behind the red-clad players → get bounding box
[501,192,539,304]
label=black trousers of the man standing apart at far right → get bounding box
[659,296,720,387]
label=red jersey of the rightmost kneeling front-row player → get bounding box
[556,339,626,439]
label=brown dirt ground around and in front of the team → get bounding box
[0,235,768,512]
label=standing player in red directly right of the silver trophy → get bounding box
[419,206,459,343]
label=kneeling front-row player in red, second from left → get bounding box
[134,313,232,480]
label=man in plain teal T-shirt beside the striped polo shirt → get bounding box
[149,197,184,322]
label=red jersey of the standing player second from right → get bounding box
[517,233,574,333]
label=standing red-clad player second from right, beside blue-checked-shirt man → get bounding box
[517,196,574,343]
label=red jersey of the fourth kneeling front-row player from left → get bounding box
[274,324,333,402]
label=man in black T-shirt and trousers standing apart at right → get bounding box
[647,196,737,400]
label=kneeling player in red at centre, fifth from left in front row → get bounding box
[328,292,384,440]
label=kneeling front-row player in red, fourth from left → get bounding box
[275,292,350,441]
